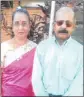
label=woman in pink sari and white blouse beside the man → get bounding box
[1,8,36,96]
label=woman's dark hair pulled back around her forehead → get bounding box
[11,7,30,37]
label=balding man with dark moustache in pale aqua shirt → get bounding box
[32,7,83,97]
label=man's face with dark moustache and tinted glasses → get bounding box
[54,12,75,40]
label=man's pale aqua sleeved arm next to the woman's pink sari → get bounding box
[32,47,48,96]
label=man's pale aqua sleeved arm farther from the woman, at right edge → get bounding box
[64,50,83,96]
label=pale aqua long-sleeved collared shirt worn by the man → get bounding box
[32,37,83,96]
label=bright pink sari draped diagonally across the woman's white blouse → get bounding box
[2,40,36,96]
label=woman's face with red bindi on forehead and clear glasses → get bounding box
[13,12,30,39]
